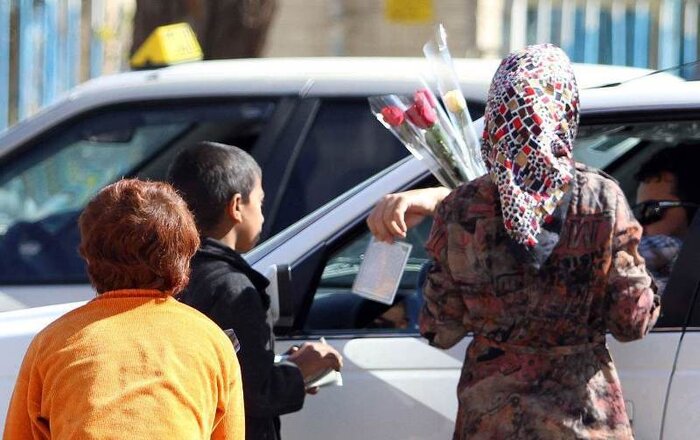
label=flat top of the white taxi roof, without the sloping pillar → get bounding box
[56,57,682,99]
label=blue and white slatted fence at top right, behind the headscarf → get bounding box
[504,0,699,69]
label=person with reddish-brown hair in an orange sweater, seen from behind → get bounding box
[4,179,245,440]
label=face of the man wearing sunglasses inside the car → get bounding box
[637,173,688,237]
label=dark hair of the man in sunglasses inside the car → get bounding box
[634,143,700,221]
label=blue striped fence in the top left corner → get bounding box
[0,0,105,130]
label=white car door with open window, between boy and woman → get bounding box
[283,218,469,439]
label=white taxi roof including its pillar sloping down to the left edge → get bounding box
[0,57,683,157]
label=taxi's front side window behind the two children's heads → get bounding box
[0,102,274,284]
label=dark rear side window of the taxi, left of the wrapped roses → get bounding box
[271,98,408,231]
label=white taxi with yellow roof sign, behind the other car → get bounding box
[0,58,668,311]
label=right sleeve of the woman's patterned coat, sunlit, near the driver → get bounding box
[606,188,660,342]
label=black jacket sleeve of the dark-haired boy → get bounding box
[210,273,305,418]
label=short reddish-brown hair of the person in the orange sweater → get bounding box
[79,179,199,295]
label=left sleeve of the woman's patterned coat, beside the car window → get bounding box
[419,196,468,348]
